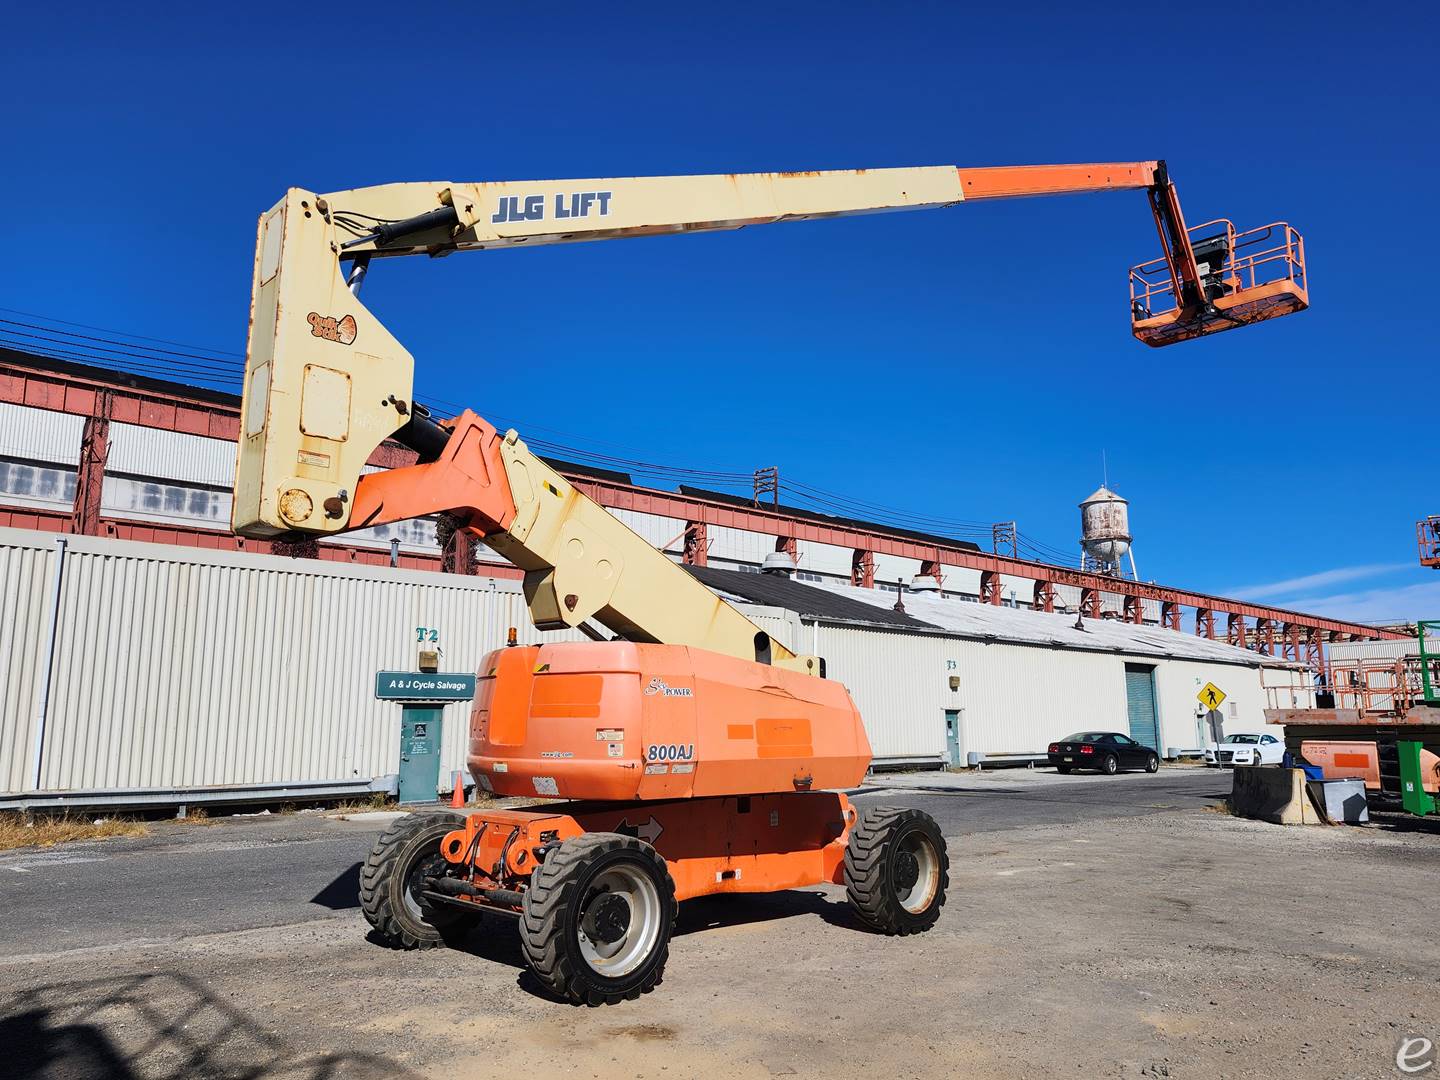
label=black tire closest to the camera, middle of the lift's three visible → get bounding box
[520,832,678,1005]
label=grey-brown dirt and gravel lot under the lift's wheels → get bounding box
[0,788,1440,1079]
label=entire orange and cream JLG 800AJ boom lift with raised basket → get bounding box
[233,161,1306,1004]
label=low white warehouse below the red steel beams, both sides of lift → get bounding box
[0,528,1308,806]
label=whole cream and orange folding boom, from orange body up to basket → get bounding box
[232,161,1305,670]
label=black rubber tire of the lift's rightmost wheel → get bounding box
[845,806,950,935]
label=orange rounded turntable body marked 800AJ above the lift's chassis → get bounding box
[468,641,871,802]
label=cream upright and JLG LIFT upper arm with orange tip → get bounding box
[233,161,1156,550]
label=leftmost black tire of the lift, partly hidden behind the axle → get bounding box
[360,812,475,949]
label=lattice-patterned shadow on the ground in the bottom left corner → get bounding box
[0,973,419,1080]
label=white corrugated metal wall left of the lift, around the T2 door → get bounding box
[0,530,573,793]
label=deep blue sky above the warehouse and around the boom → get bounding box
[0,3,1440,618]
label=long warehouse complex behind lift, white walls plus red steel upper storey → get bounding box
[0,348,1359,805]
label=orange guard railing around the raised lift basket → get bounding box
[1130,217,1305,320]
